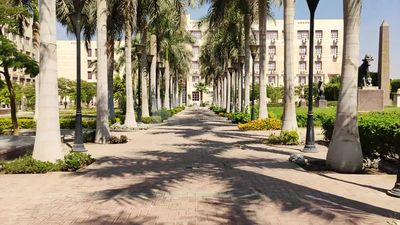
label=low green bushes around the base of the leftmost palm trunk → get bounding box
[0,152,94,174]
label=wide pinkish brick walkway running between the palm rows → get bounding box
[0,109,400,225]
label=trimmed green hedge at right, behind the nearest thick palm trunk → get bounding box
[322,112,400,158]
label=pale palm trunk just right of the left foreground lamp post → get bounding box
[95,0,111,144]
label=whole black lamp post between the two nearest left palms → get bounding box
[69,0,87,152]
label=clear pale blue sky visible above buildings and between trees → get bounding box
[57,0,400,78]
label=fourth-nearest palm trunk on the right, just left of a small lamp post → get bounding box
[243,14,251,113]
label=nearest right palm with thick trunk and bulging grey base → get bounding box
[326,0,363,173]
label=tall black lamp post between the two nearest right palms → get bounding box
[303,0,319,152]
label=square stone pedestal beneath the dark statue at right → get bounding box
[358,87,384,112]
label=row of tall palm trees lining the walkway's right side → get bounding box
[200,0,362,172]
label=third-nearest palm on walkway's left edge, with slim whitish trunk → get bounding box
[120,0,137,128]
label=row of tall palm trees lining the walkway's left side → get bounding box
[20,0,194,162]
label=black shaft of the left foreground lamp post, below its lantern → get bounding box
[72,12,87,152]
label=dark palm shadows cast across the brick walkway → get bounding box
[79,108,400,224]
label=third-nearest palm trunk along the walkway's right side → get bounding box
[258,0,268,119]
